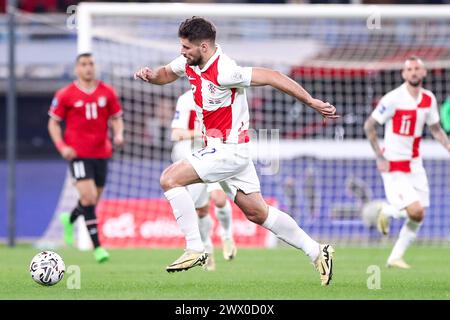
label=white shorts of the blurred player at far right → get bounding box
[381,161,430,209]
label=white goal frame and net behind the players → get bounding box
[37,3,450,247]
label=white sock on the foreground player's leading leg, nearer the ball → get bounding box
[164,187,205,252]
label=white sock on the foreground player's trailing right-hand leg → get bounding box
[262,206,319,262]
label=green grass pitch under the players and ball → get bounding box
[0,245,450,300]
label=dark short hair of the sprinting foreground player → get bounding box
[178,16,216,42]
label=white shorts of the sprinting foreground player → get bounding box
[187,141,261,200]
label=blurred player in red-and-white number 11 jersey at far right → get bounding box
[364,56,450,269]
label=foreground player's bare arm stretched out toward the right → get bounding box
[251,68,339,119]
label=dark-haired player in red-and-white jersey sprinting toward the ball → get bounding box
[135,17,338,285]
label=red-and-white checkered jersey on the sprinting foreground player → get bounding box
[170,46,252,143]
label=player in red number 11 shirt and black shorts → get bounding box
[48,53,123,262]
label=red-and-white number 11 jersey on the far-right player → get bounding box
[372,83,439,161]
